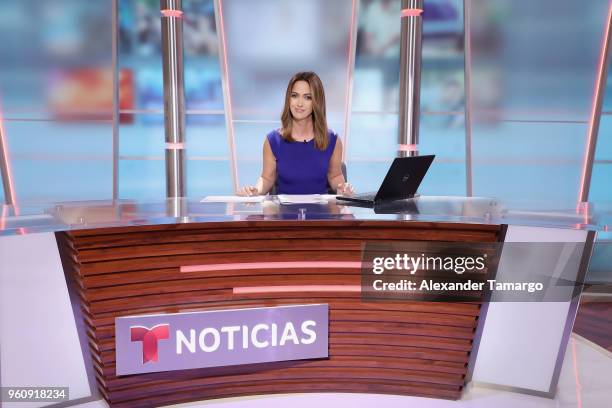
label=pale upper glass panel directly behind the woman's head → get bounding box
[221,0,352,126]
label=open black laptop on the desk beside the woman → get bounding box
[336,155,436,207]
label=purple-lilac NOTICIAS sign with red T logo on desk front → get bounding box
[115,305,328,375]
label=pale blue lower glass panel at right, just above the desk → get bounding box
[472,122,587,207]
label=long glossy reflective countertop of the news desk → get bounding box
[0,196,603,235]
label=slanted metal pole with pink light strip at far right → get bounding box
[578,1,612,203]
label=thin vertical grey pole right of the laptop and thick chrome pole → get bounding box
[463,0,473,197]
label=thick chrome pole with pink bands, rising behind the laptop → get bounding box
[398,0,423,157]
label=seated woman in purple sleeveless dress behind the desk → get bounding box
[238,72,353,196]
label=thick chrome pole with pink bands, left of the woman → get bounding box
[160,0,186,201]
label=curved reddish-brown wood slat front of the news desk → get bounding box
[57,220,501,407]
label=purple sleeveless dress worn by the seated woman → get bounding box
[266,130,338,194]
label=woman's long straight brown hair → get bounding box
[280,71,329,150]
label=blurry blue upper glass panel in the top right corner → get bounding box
[470,0,609,122]
